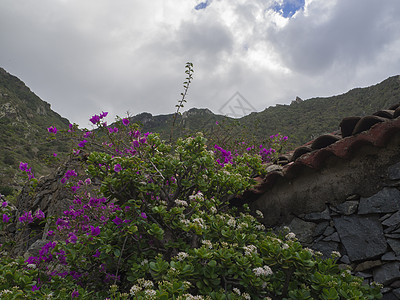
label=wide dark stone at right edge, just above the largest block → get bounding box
[358,188,400,215]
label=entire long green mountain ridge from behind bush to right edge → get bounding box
[132,76,400,147]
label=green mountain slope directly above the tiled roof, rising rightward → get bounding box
[240,76,400,145]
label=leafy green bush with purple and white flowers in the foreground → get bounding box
[0,112,381,299]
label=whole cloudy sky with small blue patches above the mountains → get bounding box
[0,0,400,127]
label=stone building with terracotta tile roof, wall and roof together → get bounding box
[247,105,400,299]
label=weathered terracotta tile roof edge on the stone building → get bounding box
[247,104,400,200]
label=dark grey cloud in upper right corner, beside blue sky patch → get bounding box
[268,0,400,74]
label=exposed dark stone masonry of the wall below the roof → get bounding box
[286,162,400,299]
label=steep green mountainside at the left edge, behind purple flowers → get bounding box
[0,68,69,194]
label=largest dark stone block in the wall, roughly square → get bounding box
[334,215,387,262]
